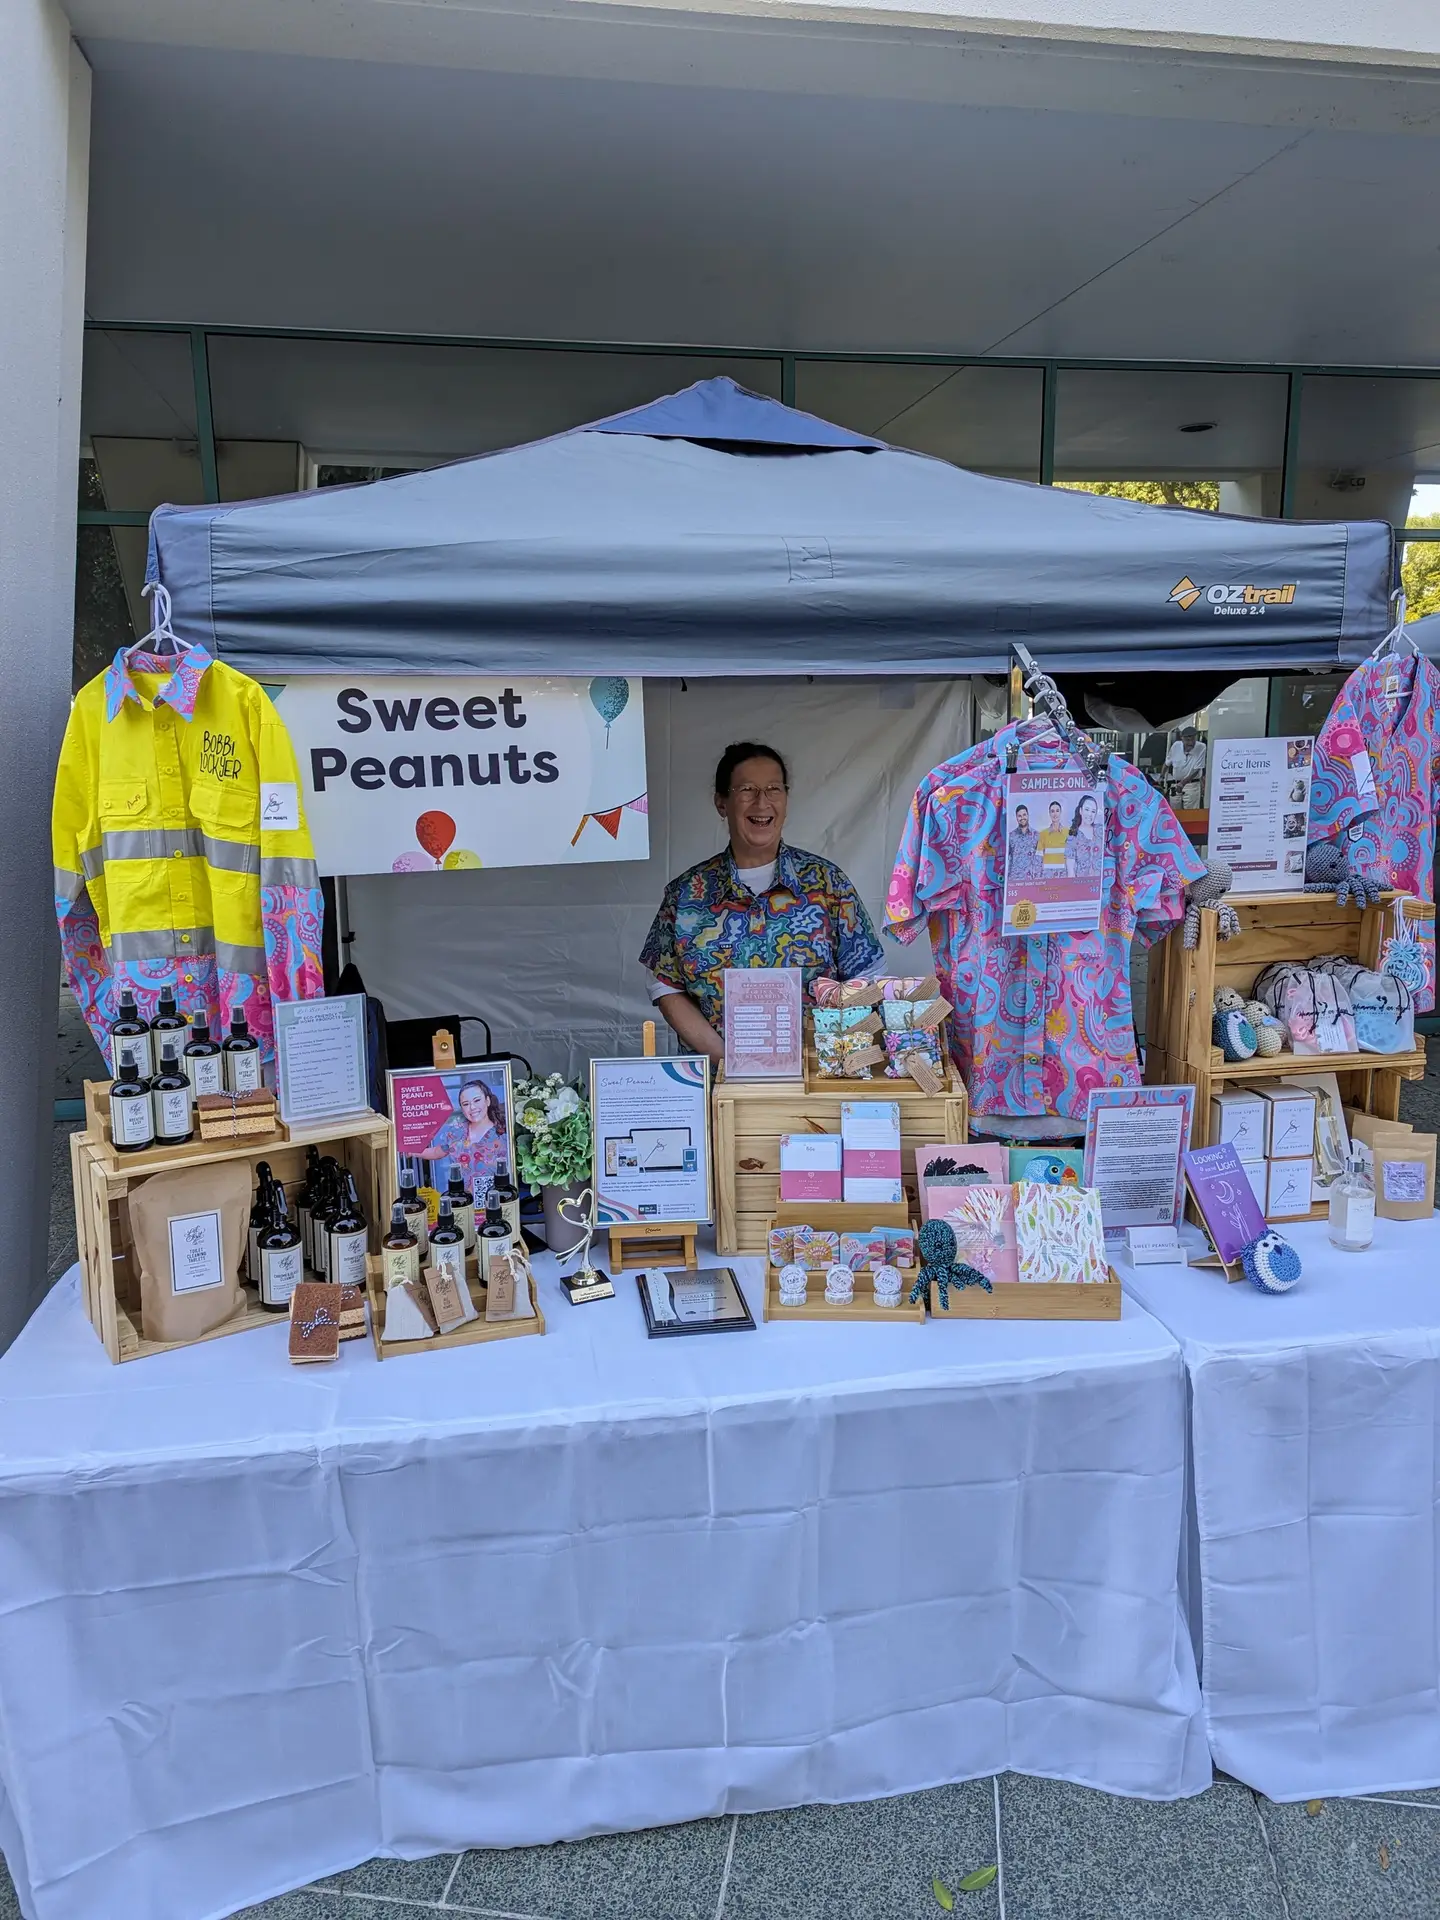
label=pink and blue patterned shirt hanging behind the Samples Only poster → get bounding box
[885,726,1206,1121]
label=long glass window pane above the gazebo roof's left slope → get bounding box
[209,334,780,464]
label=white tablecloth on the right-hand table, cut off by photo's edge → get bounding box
[1116,1219,1440,1799]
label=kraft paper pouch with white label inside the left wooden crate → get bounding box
[131,1160,250,1340]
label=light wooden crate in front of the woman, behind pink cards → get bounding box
[712,1068,970,1251]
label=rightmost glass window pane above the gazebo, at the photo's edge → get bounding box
[1294,374,1440,526]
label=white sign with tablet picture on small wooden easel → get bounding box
[589,1054,712,1267]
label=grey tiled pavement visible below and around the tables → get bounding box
[19,1043,1440,1920]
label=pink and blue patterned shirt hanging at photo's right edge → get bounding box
[1309,655,1440,1012]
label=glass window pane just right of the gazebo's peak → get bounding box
[795,361,1044,480]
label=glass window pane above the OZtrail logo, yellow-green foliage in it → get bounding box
[1054,369,1288,515]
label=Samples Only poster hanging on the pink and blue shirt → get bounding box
[1002,772,1106,935]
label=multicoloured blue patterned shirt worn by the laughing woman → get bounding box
[639,841,885,1025]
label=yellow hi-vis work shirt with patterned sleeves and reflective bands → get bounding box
[52,647,324,1060]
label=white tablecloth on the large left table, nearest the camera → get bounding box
[0,1261,1210,1920]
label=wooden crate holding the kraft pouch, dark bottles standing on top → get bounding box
[69,1081,390,1361]
